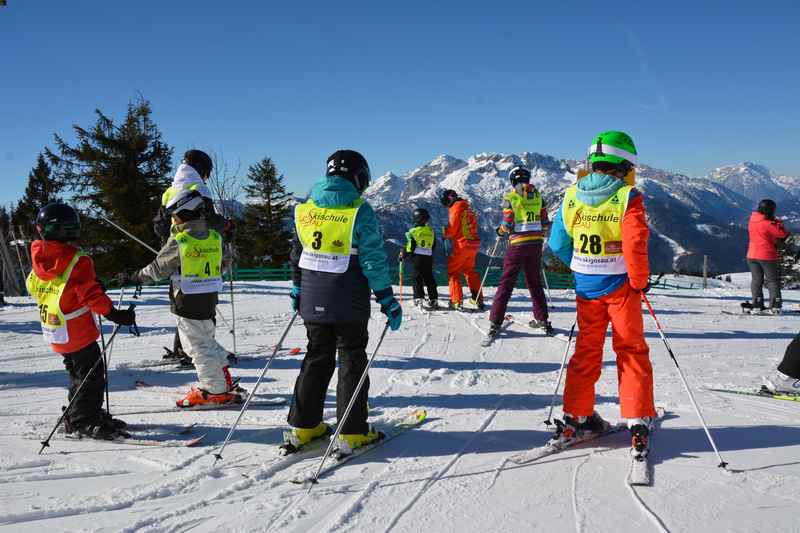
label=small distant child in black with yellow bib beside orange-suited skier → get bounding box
[400,207,439,309]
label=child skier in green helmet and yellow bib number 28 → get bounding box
[548,131,655,448]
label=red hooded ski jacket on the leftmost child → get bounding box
[31,241,113,354]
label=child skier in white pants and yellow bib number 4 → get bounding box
[120,189,242,408]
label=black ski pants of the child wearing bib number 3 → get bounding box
[288,321,369,434]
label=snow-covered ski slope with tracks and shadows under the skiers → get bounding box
[0,283,800,533]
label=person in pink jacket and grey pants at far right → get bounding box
[742,199,789,314]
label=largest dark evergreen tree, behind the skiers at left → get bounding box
[46,99,172,277]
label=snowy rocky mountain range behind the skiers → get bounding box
[364,152,800,272]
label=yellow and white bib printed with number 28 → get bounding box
[562,185,633,275]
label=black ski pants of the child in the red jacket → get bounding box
[61,342,106,426]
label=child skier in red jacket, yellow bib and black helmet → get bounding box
[27,202,136,440]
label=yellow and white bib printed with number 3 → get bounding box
[294,198,364,274]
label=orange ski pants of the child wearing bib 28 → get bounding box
[564,283,656,418]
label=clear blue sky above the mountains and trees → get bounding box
[0,0,800,204]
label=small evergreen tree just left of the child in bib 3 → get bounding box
[236,157,292,266]
